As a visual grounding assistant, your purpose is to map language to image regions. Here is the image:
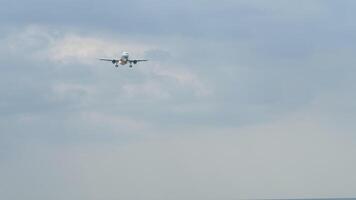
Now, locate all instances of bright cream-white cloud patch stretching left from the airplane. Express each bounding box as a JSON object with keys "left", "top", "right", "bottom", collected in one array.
[{"left": 2, "top": 25, "right": 154, "bottom": 64}]
